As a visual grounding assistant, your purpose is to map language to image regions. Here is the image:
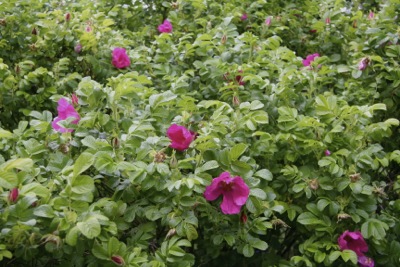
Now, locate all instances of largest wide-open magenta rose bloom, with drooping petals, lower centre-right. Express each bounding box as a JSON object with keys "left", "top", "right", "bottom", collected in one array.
[{"left": 204, "top": 172, "right": 250, "bottom": 214}]
